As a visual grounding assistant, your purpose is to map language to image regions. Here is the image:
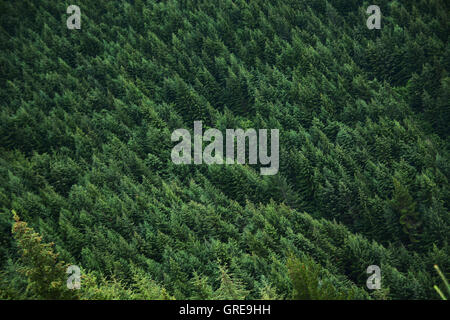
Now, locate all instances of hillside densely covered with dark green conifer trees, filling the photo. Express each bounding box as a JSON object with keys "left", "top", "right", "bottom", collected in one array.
[{"left": 0, "top": 0, "right": 450, "bottom": 299}]
